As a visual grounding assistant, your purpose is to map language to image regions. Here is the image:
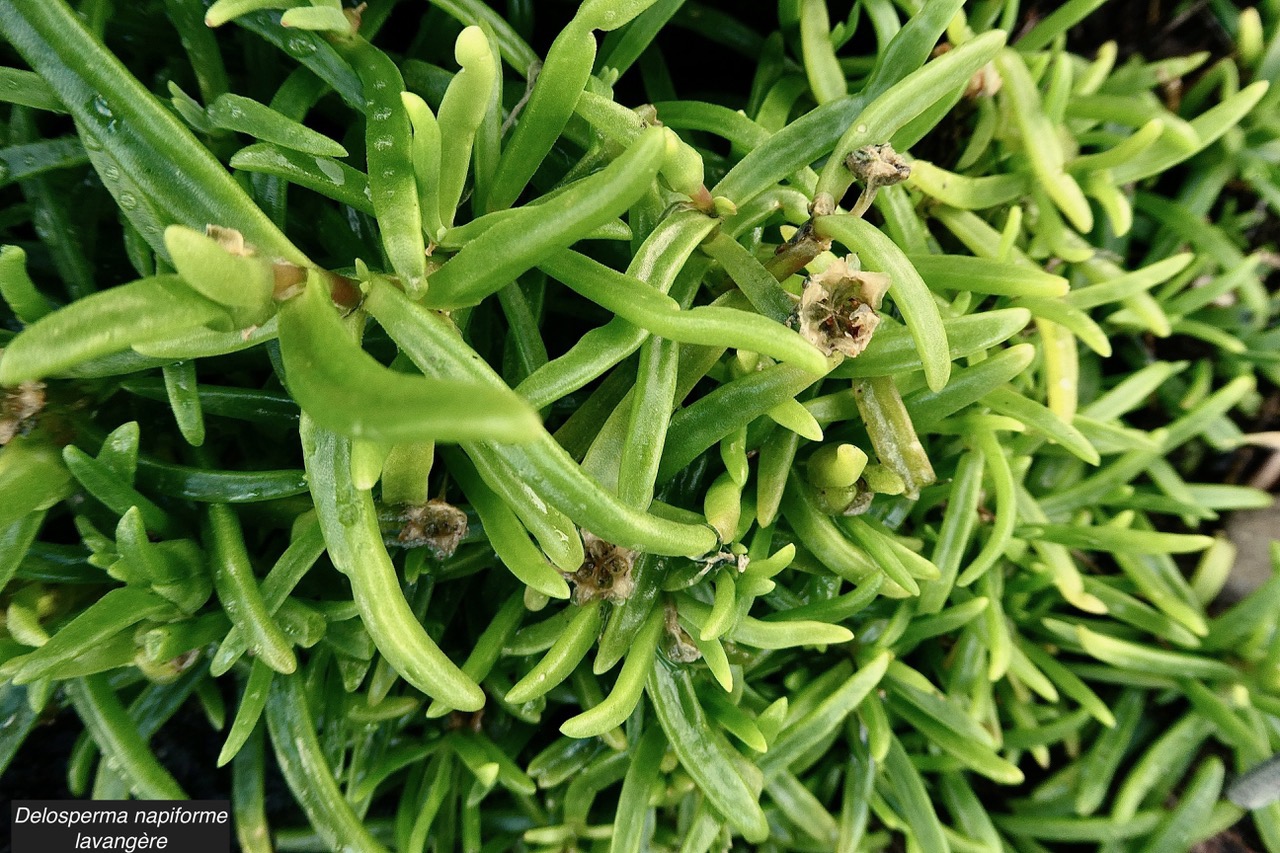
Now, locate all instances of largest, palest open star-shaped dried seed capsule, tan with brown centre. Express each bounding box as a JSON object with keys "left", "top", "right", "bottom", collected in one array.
[{"left": 796, "top": 256, "right": 890, "bottom": 359}]
